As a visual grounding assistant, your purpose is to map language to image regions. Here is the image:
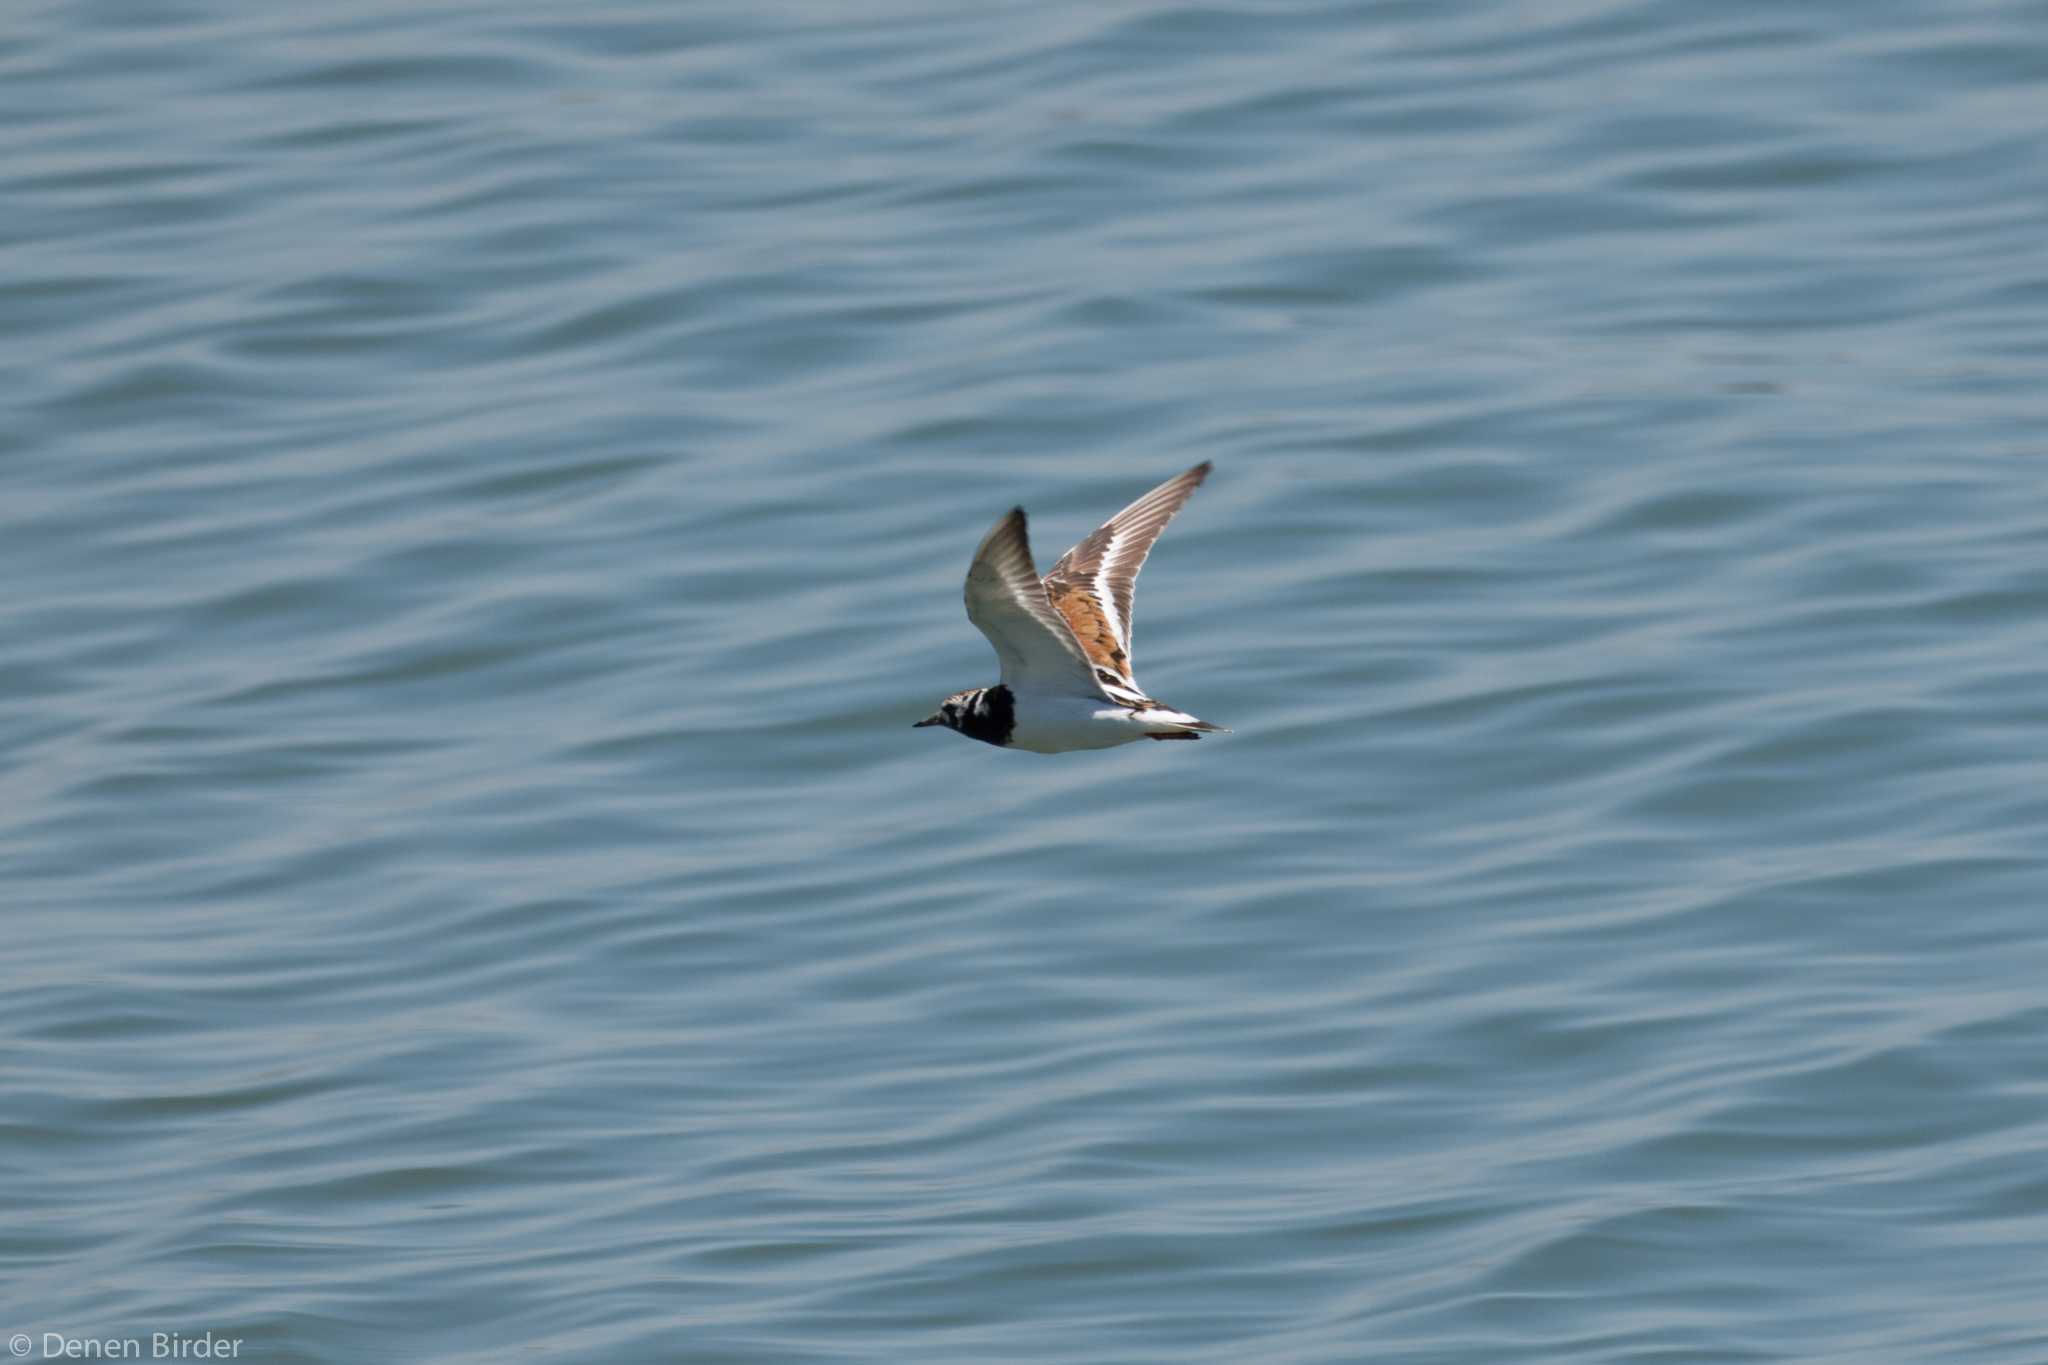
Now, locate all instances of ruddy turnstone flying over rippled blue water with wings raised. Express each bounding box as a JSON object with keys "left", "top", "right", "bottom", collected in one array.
[{"left": 911, "top": 460, "right": 1223, "bottom": 753}]
